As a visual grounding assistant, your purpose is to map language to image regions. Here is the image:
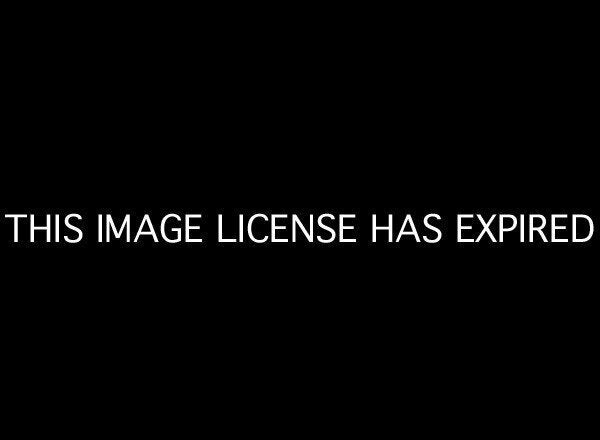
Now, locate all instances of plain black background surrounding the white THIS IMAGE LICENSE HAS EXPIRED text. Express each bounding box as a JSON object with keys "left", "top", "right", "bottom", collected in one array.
[{"left": 1, "top": 5, "right": 598, "bottom": 433}]
